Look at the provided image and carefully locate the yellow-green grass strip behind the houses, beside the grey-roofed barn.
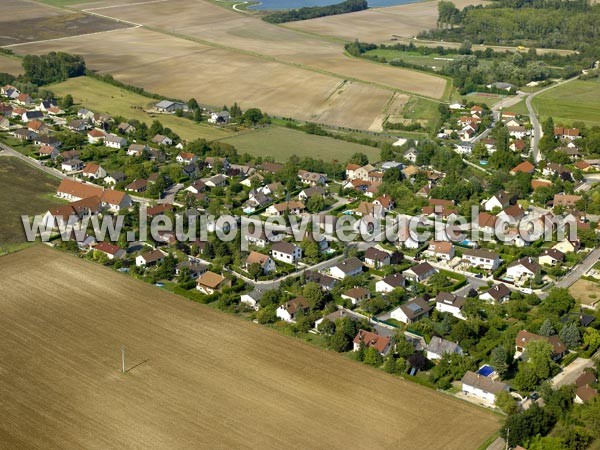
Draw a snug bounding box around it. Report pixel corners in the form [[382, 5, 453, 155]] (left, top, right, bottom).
[[48, 77, 233, 141]]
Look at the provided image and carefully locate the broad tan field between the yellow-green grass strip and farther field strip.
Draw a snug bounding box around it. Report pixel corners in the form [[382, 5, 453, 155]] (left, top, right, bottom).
[[15, 28, 398, 129]]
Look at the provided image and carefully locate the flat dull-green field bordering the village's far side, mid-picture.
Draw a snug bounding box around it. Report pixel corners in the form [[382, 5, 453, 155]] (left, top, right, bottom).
[[220, 126, 379, 162]]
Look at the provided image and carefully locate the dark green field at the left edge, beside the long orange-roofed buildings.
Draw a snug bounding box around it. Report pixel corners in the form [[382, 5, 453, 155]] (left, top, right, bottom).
[[0, 156, 61, 254]]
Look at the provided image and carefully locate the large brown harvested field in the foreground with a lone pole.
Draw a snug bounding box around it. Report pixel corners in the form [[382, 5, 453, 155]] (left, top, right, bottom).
[[0, 246, 498, 450]]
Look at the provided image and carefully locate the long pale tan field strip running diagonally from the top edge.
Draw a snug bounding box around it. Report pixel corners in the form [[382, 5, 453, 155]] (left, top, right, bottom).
[[77, 0, 446, 98]]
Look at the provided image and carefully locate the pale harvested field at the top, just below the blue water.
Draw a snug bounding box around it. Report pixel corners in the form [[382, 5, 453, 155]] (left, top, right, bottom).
[[285, 0, 487, 42]]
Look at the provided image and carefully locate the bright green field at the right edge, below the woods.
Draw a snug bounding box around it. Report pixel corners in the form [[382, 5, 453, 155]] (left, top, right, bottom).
[[533, 78, 600, 126]]
